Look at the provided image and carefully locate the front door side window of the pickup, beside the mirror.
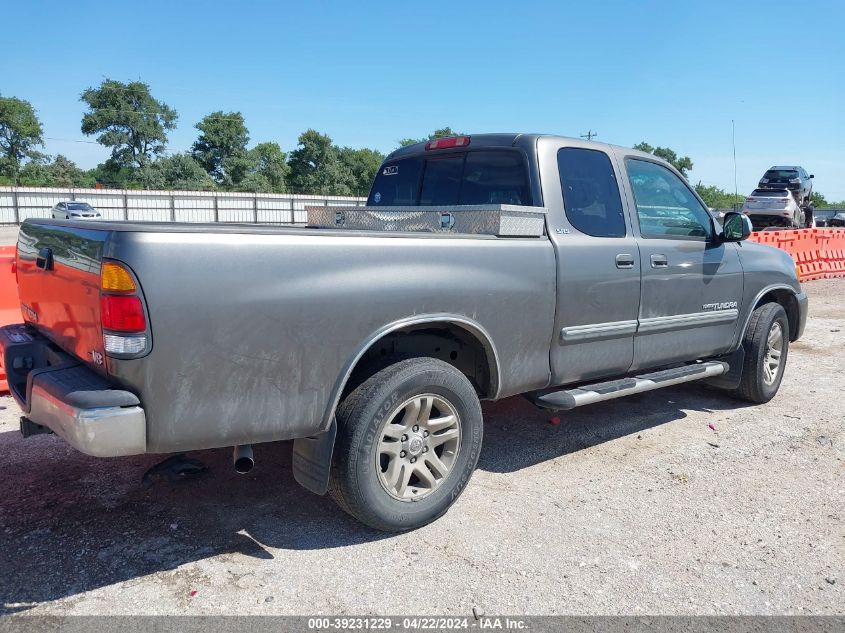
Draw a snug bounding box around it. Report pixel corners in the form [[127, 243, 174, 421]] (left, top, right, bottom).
[[625, 158, 713, 240]]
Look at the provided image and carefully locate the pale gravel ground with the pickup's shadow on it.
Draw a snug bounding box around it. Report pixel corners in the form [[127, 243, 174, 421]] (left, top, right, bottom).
[[0, 280, 845, 615]]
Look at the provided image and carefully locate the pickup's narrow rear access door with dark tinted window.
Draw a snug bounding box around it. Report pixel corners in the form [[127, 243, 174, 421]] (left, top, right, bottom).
[[538, 139, 640, 385]]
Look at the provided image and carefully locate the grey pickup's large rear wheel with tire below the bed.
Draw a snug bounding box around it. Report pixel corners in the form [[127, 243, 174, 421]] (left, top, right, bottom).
[[329, 358, 483, 532]]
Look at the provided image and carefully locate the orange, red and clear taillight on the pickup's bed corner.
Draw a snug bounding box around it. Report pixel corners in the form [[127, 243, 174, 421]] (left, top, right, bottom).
[[100, 262, 147, 354]]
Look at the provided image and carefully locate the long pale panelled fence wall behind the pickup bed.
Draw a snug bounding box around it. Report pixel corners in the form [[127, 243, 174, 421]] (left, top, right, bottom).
[[0, 187, 366, 224]]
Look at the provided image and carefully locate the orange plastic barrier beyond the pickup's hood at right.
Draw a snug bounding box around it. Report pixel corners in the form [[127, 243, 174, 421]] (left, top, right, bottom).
[[749, 229, 845, 281]]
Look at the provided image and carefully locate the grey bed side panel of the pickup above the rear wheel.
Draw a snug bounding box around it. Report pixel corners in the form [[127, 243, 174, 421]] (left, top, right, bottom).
[[107, 231, 555, 452]]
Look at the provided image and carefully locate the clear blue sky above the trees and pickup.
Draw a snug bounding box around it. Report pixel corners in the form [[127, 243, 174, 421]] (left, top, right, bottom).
[[0, 0, 845, 200]]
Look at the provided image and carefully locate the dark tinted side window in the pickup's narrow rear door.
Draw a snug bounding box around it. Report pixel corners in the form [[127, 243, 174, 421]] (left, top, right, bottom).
[[557, 147, 626, 237]]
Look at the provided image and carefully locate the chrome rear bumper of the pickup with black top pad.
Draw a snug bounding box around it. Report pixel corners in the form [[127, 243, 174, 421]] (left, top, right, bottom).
[[0, 325, 147, 457]]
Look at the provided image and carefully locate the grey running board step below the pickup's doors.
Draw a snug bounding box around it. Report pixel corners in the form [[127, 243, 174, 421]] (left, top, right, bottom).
[[531, 361, 730, 411]]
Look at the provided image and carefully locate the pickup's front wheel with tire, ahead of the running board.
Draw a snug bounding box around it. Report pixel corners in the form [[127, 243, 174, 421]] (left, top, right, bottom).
[[734, 303, 789, 404]]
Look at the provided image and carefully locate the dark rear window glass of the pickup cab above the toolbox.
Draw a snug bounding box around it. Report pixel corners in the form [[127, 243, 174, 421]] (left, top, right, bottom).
[[367, 150, 533, 206]]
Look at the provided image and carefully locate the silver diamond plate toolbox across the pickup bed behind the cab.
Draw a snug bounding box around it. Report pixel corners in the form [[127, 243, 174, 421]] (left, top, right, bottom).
[[305, 204, 546, 237]]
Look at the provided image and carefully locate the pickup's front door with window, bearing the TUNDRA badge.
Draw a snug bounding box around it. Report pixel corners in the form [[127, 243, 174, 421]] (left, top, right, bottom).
[[621, 156, 743, 369]]
